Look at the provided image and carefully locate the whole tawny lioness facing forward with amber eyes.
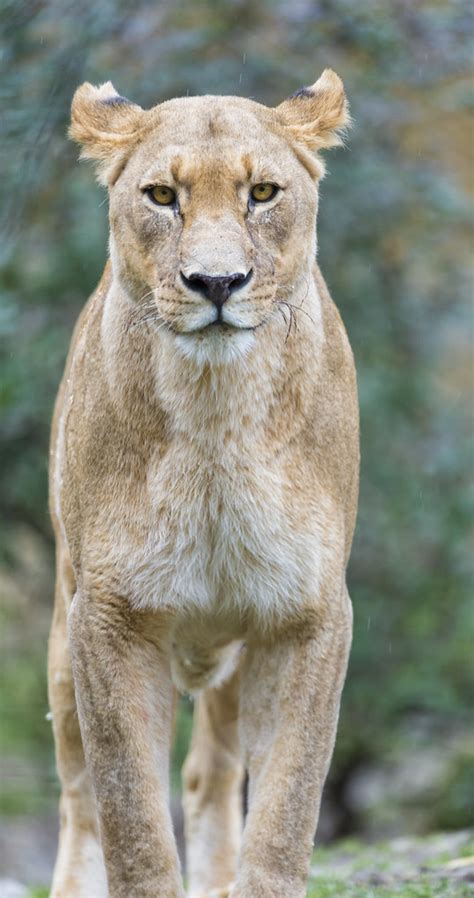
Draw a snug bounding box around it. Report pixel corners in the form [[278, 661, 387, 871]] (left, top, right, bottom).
[[49, 70, 358, 898]]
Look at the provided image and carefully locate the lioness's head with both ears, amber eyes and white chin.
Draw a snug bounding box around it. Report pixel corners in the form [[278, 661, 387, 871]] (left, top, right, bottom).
[[70, 69, 348, 355]]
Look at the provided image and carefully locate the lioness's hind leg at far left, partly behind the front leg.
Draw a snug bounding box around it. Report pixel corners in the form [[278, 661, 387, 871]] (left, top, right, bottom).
[[48, 552, 108, 898]]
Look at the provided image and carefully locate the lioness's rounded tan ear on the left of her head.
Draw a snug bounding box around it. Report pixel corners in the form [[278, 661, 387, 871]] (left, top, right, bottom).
[[69, 81, 145, 184]]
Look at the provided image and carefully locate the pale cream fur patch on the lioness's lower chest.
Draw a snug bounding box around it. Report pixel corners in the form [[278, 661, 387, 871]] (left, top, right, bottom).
[[108, 443, 324, 618]]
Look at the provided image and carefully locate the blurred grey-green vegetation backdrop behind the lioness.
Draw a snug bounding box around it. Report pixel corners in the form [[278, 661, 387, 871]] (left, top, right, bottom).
[[0, 0, 474, 881]]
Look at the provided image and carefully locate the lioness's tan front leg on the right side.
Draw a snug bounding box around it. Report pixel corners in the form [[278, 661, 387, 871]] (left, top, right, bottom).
[[234, 591, 352, 898]]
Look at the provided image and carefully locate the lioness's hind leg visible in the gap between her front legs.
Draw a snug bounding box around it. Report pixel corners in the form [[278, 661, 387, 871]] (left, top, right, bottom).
[[183, 674, 243, 898]]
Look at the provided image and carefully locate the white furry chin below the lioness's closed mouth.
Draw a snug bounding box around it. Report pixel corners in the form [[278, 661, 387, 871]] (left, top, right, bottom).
[[175, 325, 256, 365]]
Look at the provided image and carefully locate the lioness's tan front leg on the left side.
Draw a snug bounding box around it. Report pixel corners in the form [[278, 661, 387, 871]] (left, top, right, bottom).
[[69, 593, 184, 898]]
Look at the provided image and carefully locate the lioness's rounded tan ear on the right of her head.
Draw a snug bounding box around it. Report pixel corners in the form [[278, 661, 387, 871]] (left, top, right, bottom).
[[276, 69, 350, 151]]
